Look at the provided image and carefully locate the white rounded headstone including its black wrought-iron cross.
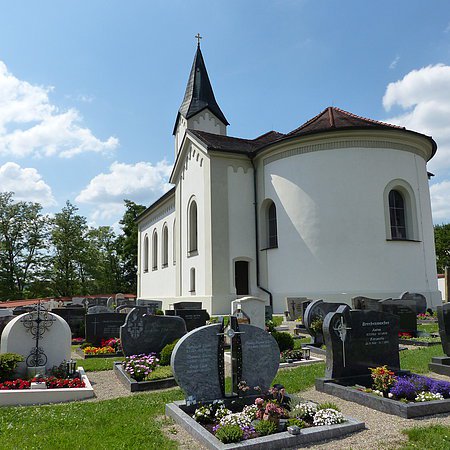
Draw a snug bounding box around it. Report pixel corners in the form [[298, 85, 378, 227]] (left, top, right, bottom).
[[0, 306, 71, 377]]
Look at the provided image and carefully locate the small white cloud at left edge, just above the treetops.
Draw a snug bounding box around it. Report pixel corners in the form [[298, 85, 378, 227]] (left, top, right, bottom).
[[0, 162, 56, 206]]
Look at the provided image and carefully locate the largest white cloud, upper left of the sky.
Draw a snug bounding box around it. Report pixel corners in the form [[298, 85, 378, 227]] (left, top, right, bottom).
[[0, 61, 119, 158]]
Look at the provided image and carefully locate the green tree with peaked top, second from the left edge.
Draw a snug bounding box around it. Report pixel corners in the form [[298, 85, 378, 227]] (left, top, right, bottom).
[[51, 201, 91, 296]]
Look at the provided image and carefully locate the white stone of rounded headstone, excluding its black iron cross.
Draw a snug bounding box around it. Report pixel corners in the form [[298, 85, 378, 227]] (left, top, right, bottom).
[[0, 312, 72, 376]]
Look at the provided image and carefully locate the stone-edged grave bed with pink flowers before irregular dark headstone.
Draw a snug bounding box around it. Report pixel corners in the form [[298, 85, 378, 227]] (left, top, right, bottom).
[[114, 353, 177, 392]]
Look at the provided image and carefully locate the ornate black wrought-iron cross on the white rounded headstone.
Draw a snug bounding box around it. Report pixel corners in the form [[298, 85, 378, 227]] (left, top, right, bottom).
[[20, 301, 56, 367]]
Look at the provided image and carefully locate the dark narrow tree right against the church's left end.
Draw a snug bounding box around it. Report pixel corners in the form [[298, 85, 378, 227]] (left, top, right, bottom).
[[118, 200, 145, 293]]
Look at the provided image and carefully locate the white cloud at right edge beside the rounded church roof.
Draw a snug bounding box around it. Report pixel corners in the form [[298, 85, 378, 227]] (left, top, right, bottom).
[[383, 64, 450, 175]]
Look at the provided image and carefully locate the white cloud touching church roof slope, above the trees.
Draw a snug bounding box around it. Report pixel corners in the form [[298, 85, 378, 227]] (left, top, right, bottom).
[[75, 160, 172, 222]]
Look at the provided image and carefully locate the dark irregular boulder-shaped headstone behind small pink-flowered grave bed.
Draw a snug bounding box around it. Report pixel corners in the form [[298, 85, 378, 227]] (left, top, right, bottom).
[[120, 307, 187, 356]]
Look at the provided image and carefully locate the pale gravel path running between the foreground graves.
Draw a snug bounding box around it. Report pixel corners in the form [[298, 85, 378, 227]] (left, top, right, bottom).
[[82, 370, 450, 450]]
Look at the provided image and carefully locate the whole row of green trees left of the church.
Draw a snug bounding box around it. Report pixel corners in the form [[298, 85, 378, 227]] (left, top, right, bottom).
[[0, 192, 145, 301]]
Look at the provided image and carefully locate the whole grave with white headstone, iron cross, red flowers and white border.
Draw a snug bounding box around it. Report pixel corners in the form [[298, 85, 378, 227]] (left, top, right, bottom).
[[0, 304, 94, 406]]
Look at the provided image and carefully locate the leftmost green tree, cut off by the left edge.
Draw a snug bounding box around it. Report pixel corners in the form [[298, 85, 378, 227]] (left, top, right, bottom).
[[0, 192, 48, 300]]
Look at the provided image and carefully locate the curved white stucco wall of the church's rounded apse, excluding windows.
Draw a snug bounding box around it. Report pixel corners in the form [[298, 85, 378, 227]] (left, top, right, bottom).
[[259, 132, 440, 312]]
